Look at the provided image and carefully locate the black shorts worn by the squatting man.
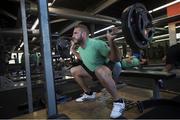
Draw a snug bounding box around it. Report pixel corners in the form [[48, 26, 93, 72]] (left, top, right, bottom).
[[73, 60, 115, 80]]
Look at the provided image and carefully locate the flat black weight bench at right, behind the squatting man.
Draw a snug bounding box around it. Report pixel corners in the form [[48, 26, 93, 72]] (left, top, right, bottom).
[[120, 70, 180, 112]]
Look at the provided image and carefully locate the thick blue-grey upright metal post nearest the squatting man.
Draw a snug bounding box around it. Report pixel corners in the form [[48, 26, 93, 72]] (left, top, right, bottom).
[[39, 0, 57, 118]]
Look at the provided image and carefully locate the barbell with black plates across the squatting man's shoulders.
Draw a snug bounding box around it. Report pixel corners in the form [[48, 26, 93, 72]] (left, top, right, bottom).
[[56, 3, 155, 57]]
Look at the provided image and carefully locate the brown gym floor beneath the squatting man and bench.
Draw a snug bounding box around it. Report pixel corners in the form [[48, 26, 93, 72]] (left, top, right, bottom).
[[15, 84, 177, 119]]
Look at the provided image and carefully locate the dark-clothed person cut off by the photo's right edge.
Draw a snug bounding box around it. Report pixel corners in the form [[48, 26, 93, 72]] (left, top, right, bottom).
[[164, 41, 180, 72]]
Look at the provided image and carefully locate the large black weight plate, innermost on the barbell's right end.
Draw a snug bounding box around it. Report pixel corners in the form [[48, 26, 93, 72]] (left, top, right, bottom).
[[122, 3, 153, 50]]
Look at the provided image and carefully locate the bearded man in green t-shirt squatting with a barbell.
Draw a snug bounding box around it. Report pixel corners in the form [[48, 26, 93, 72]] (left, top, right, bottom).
[[71, 24, 125, 118]]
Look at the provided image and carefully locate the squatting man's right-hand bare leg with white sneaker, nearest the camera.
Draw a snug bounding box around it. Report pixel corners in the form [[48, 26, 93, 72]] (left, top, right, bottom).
[[95, 66, 125, 118]]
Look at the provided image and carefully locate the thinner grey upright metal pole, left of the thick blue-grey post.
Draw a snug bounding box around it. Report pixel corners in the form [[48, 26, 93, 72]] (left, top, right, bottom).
[[20, 0, 33, 113]]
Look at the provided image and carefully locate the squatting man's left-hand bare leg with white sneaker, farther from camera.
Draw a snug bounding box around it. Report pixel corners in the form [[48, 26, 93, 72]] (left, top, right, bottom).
[[70, 65, 96, 102]]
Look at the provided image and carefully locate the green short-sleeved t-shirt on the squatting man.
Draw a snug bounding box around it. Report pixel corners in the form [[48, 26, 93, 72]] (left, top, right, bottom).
[[78, 38, 110, 71]]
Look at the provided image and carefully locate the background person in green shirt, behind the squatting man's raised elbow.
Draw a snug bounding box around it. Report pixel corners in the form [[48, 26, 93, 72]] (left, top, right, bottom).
[[122, 50, 140, 69]]
